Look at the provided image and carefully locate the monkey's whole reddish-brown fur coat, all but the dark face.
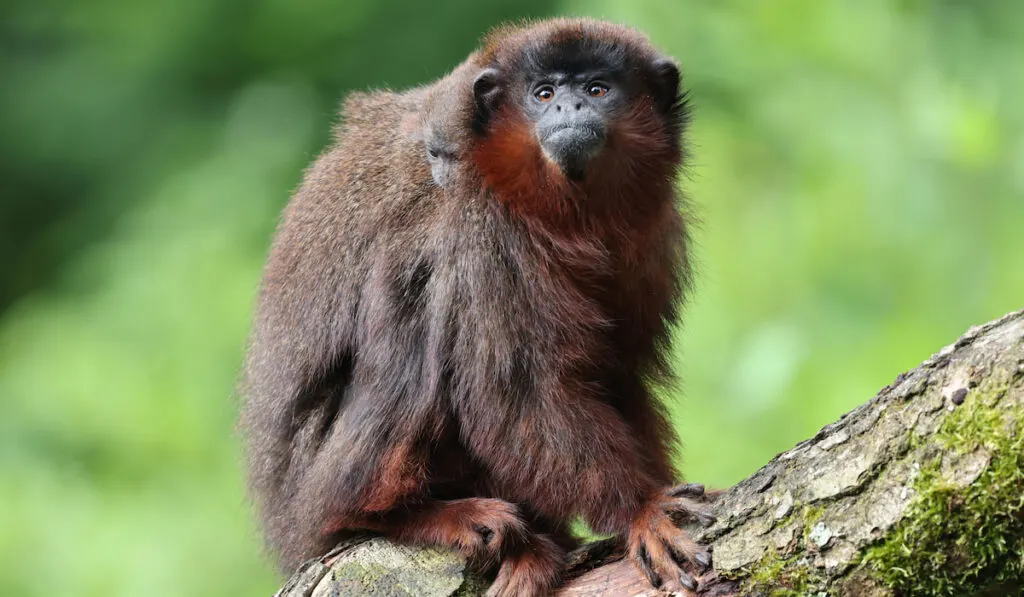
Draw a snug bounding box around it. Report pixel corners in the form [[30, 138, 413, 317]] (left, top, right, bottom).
[[242, 19, 696, 596]]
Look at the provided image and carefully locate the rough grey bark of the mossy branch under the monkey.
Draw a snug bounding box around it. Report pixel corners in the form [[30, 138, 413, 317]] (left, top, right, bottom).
[[278, 310, 1024, 597]]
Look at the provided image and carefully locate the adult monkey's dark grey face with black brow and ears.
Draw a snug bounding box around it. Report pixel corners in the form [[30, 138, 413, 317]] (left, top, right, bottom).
[[473, 36, 679, 180]]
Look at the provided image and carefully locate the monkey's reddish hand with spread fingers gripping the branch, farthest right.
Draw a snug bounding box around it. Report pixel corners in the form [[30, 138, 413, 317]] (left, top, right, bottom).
[[628, 483, 715, 594]]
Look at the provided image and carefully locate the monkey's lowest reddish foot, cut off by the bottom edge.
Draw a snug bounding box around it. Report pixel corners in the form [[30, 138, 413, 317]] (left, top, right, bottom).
[[484, 535, 567, 597]]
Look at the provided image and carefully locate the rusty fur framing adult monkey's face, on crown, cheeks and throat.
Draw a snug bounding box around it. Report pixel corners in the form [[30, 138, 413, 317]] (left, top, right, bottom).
[[470, 18, 686, 228]]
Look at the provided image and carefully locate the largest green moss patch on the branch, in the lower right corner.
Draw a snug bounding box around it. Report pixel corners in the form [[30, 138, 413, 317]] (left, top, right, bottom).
[[864, 385, 1024, 597]]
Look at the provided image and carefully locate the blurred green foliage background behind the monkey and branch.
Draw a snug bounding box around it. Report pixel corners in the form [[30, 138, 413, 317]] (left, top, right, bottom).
[[0, 0, 1024, 597]]
